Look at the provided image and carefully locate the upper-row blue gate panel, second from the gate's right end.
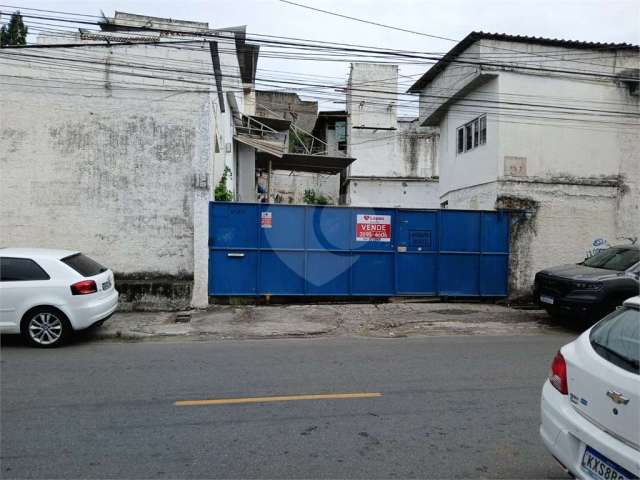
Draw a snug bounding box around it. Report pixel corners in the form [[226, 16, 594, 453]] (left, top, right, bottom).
[[440, 210, 482, 252]]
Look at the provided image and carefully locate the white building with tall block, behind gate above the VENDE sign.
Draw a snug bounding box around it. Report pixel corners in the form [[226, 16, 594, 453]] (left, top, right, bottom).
[[343, 63, 439, 208]]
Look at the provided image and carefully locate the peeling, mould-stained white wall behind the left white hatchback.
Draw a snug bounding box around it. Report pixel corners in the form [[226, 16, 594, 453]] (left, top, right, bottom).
[[0, 35, 242, 307]]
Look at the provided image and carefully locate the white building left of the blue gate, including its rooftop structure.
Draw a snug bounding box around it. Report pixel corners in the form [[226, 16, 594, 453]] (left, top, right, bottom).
[[0, 12, 257, 308]]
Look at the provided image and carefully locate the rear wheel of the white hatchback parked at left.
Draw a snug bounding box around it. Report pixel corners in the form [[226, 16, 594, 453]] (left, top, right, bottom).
[[21, 307, 72, 348]]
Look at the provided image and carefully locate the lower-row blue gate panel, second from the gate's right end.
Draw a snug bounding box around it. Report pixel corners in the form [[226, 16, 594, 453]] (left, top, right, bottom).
[[438, 254, 480, 297]]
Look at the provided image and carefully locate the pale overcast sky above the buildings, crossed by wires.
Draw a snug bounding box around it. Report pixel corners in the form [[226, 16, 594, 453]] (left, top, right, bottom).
[[2, 0, 640, 114]]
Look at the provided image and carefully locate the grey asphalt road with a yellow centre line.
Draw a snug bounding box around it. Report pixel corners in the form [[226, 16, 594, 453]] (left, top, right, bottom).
[[1, 332, 572, 478]]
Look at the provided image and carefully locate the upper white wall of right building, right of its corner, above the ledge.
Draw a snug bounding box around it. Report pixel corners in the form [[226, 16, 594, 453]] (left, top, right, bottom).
[[499, 72, 640, 178]]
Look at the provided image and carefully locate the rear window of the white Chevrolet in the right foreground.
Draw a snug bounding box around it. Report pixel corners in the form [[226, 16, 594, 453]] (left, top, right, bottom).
[[589, 307, 640, 373]]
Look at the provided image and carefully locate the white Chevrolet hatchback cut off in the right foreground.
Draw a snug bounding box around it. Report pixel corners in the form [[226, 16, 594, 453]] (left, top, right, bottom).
[[540, 297, 640, 480]]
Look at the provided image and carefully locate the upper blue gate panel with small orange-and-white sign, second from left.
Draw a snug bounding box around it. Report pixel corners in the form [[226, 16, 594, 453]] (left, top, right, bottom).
[[260, 205, 305, 250]]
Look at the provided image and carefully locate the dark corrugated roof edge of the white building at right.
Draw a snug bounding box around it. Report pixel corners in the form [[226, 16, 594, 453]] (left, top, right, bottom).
[[407, 32, 640, 93]]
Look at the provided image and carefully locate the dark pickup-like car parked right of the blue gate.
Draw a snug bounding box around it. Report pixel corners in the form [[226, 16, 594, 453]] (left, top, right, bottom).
[[534, 245, 640, 321]]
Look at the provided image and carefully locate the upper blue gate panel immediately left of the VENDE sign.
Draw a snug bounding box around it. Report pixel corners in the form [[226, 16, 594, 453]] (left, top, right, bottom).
[[305, 207, 353, 250]]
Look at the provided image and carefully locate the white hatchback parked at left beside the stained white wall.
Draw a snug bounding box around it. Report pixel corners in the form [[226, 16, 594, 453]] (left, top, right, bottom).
[[0, 248, 118, 347]]
